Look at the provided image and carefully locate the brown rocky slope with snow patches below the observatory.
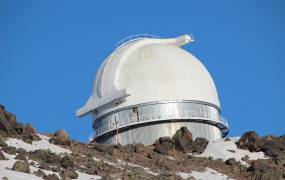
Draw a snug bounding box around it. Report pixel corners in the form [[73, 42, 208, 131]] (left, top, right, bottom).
[[0, 105, 285, 180]]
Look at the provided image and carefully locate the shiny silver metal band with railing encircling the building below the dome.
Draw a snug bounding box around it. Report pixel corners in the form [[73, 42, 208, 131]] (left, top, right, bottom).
[[93, 101, 228, 138]]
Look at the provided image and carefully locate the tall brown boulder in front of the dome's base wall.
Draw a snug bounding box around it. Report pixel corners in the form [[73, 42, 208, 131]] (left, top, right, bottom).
[[172, 127, 193, 152]]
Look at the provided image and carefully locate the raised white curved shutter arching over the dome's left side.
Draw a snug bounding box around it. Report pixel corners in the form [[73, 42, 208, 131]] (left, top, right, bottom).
[[76, 35, 196, 116]]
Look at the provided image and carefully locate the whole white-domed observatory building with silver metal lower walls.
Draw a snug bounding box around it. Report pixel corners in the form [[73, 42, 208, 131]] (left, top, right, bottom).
[[76, 35, 229, 145]]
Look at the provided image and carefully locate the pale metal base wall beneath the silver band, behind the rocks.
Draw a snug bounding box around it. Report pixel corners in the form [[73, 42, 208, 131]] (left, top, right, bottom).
[[95, 121, 222, 145]]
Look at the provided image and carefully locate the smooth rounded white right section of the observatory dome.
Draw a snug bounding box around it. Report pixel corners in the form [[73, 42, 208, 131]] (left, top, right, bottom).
[[115, 43, 220, 107]]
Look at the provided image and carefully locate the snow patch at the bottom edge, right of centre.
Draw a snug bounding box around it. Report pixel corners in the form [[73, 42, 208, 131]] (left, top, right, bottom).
[[176, 168, 232, 180]]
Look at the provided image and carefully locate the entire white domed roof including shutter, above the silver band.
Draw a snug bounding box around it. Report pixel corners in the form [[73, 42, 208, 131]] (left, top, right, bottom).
[[77, 35, 220, 116]]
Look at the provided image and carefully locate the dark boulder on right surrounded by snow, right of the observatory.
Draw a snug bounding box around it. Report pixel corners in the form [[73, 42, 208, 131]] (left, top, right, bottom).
[[236, 131, 263, 152]]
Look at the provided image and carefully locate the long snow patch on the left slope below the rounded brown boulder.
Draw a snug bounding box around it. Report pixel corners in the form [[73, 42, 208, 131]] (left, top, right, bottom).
[[6, 134, 71, 154]]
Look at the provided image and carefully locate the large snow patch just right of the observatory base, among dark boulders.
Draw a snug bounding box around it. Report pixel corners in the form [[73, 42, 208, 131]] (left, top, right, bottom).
[[195, 137, 266, 165]]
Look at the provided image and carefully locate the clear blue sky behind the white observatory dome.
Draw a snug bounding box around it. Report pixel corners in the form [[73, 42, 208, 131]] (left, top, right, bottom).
[[0, 0, 285, 141]]
